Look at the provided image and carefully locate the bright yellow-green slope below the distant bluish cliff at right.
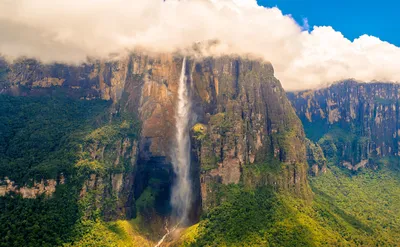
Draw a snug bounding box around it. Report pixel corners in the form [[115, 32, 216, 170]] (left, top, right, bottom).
[[311, 166, 400, 246]]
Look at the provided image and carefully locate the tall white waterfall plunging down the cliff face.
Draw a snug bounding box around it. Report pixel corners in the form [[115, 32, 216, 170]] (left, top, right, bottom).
[[171, 57, 192, 224]]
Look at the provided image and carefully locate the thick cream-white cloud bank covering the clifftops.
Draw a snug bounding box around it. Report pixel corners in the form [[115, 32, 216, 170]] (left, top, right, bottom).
[[0, 0, 400, 90]]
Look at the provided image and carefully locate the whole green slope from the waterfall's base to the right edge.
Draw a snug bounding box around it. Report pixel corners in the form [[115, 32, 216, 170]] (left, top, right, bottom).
[[176, 161, 400, 246]]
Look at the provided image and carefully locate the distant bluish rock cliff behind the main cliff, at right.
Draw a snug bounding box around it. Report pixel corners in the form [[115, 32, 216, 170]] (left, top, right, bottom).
[[288, 81, 400, 170]]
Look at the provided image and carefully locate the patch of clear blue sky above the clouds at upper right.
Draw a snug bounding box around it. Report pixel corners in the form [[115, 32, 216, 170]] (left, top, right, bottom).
[[257, 0, 400, 47]]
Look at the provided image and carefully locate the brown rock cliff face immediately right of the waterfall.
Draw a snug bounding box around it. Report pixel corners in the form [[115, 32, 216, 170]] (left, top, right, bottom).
[[188, 57, 308, 210]]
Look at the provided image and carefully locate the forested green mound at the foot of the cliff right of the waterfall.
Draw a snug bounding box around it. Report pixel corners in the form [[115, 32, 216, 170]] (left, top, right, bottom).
[[190, 188, 318, 246]]
